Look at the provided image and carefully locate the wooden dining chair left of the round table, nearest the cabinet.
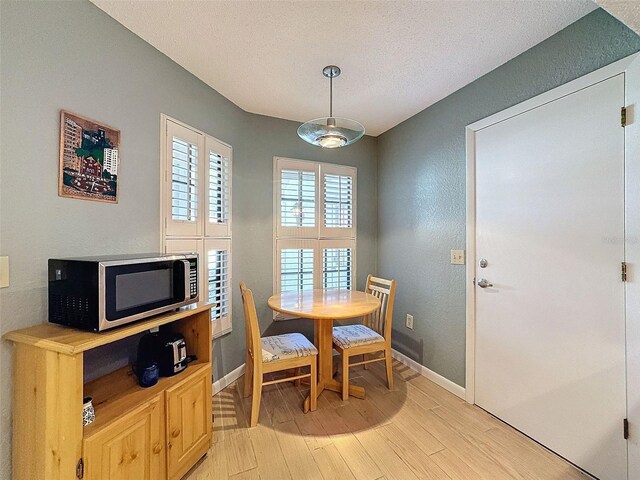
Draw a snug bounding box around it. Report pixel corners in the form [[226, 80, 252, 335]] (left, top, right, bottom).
[[240, 282, 318, 427]]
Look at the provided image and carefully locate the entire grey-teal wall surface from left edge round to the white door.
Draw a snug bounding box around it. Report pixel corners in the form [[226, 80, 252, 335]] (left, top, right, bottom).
[[0, 1, 640, 479]]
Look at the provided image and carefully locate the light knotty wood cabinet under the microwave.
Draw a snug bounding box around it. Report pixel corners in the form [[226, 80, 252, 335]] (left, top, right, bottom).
[[3, 303, 212, 480]]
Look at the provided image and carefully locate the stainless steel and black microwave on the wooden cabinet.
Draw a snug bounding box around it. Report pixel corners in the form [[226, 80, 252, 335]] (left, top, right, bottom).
[[49, 253, 198, 332]]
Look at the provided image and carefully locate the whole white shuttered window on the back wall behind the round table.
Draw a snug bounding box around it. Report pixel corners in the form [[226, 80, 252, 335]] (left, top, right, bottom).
[[273, 157, 357, 304]]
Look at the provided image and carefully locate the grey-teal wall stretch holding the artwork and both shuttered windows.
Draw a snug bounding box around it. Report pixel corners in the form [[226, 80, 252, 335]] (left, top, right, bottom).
[[0, 0, 377, 479]]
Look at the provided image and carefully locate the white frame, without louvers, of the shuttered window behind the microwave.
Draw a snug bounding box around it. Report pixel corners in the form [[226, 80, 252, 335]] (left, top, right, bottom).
[[160, 114, 233, 338]]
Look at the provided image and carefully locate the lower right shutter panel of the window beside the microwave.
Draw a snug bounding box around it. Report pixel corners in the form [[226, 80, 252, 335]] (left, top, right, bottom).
[[203, 238, 232, 337]]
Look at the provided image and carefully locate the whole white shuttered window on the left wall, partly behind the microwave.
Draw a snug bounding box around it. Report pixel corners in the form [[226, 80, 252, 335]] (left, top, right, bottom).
[[160, 114, 233, 337]]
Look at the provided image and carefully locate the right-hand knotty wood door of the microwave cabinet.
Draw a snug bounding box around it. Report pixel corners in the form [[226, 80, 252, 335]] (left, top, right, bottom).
[[166, 368, 212, 479]]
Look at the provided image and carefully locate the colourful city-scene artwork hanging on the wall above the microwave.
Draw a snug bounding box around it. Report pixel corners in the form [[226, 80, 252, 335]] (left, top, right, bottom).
[[58, 110, 120, 203]]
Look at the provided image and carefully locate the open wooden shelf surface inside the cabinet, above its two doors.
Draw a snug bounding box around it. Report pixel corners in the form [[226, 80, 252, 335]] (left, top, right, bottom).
[[84, 361, 209, 439]]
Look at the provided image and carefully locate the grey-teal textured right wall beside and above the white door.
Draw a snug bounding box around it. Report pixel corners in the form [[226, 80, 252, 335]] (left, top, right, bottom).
[[378, 10, 640, 386]]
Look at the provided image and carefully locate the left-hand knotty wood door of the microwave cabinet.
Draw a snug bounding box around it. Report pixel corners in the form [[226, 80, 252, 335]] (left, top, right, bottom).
[[84, 396, 166, 480]]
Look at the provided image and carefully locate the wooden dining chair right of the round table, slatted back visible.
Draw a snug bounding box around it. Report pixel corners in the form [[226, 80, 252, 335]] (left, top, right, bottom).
[[333, 275, 396, 400]]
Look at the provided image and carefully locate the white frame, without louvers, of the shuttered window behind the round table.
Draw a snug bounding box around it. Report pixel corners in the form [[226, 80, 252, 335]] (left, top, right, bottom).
[[273, 157, 357, 302]]
